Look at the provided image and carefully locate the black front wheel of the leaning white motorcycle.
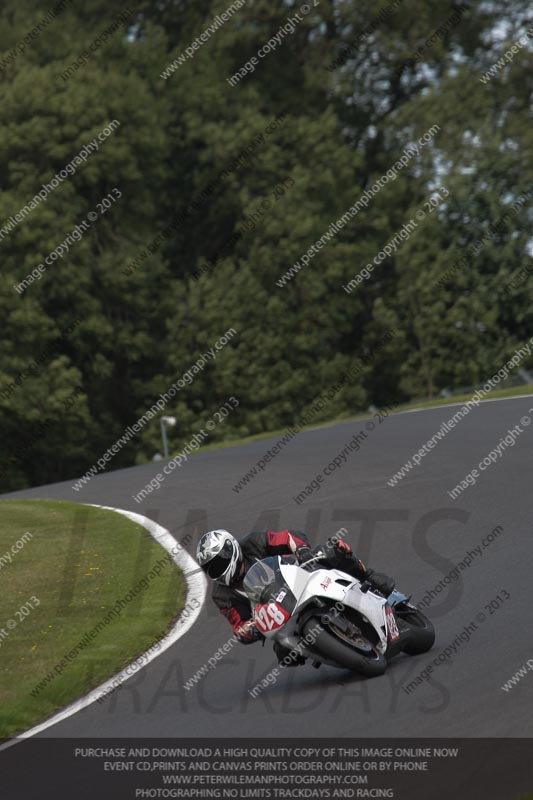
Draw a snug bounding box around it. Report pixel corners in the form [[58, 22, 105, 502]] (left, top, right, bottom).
[[302, 617, 387, 678]]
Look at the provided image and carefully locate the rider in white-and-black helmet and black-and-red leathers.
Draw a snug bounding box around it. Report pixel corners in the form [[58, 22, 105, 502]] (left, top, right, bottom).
[[196, 528, 394, 666]]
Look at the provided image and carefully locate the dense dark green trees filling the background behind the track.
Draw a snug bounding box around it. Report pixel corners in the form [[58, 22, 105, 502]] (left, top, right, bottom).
[[0, 0, 533, 490]]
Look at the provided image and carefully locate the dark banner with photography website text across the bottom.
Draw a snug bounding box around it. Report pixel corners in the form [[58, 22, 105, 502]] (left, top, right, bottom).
[[0, 738, 533, 800]]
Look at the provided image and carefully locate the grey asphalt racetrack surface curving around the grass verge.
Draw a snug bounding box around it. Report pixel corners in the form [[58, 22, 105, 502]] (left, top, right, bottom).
[[4, 396, 533, 738]]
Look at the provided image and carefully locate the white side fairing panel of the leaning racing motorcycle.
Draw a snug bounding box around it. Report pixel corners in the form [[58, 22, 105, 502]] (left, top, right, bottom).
[[265, 562, 387, 653]]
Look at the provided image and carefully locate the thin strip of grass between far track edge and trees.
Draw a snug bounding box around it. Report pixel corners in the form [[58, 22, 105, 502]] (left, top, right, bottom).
[[184, 384, 533, 455]]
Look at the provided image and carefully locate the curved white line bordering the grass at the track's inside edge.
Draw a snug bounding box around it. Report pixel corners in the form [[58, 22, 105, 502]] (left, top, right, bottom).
[[0, 503, 207, 750]]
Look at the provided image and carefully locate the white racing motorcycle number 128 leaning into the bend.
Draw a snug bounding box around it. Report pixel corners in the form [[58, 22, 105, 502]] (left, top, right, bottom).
[[243, 553, 435, 677]]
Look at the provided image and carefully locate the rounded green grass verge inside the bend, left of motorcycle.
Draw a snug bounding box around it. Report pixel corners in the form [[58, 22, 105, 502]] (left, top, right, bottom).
[[0, 500, 185, 737]]
